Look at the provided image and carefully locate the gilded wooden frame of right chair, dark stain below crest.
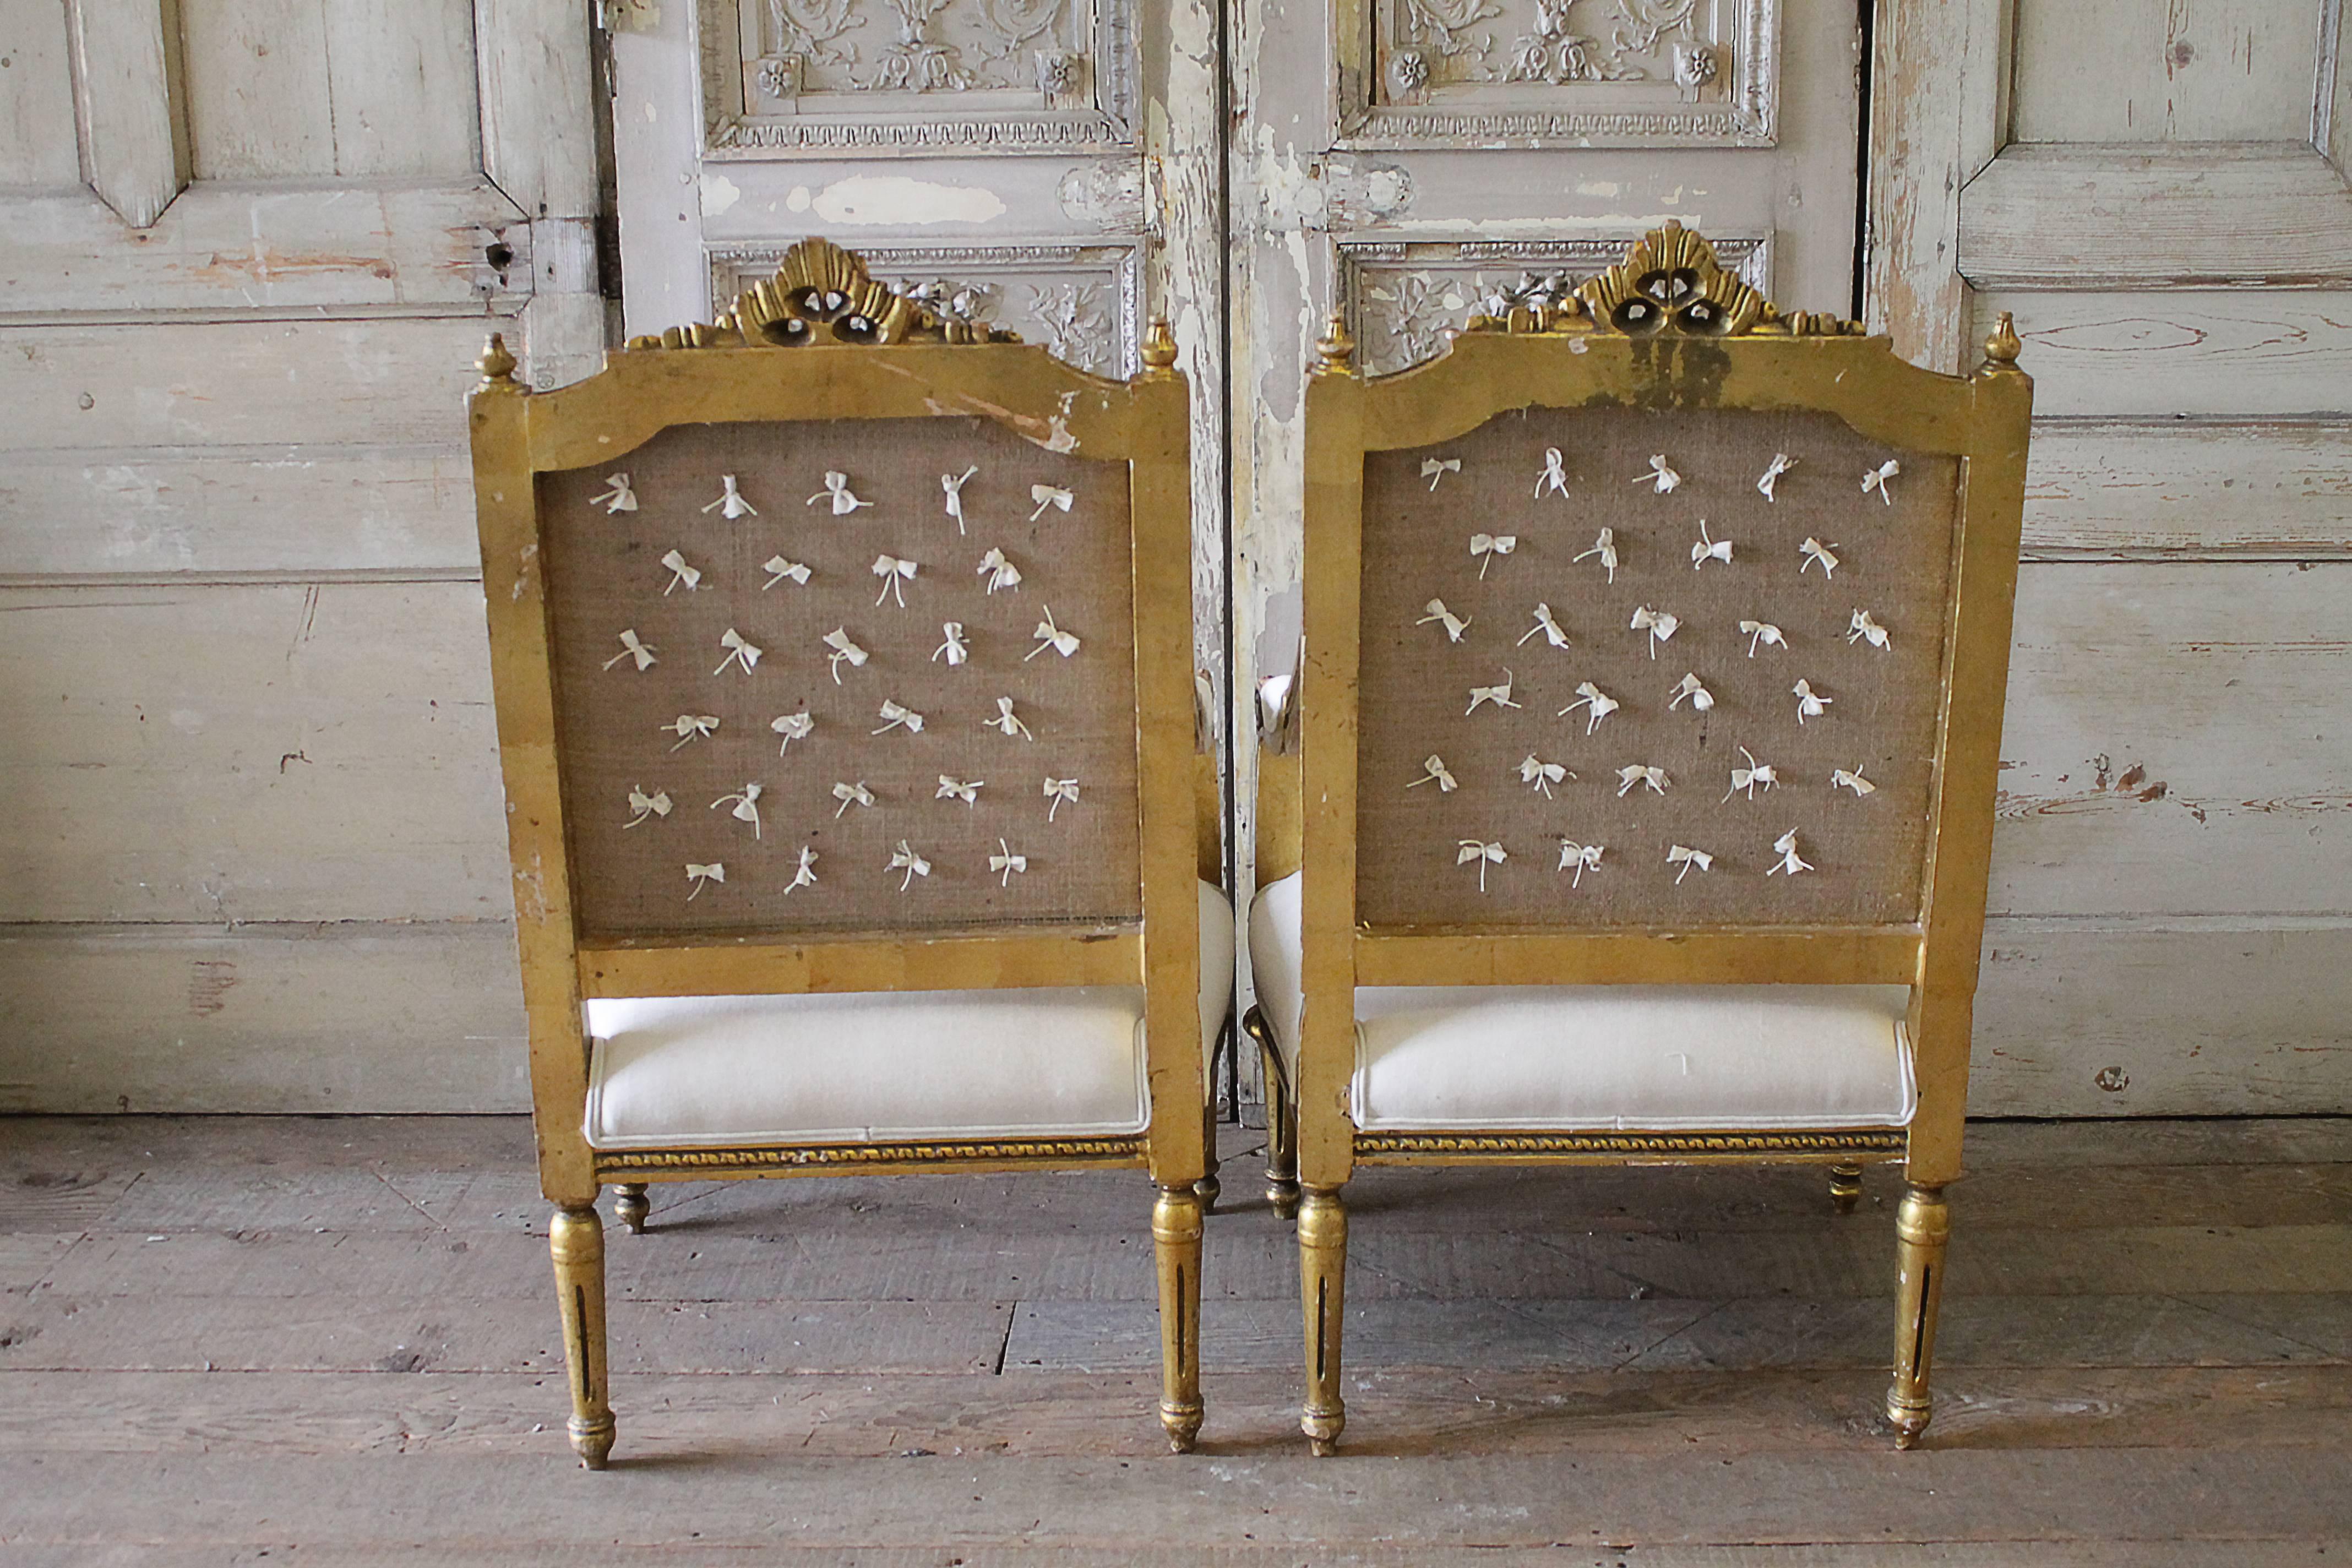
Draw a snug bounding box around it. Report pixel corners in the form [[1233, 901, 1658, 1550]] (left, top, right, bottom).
[[1289, 224, 2032, 1453]]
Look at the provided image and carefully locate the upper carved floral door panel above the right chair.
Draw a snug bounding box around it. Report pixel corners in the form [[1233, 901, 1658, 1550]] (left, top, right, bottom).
[[1343, 0, 1781, 148]]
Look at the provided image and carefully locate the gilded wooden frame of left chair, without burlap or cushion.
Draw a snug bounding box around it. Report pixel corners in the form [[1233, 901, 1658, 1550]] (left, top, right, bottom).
[[468, 240, 1216, 1469]]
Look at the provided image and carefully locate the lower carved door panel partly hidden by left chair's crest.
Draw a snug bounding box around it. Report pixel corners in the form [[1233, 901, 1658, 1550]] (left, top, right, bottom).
[[710, 240, 1143, 376]]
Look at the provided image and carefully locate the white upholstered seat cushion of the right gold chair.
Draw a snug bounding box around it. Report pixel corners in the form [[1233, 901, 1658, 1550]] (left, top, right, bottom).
[[1249, 874, 1919, 1131]]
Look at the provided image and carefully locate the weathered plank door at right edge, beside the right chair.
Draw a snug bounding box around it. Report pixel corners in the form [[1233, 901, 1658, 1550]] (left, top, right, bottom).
[[1870, 0, 2352, 1117]]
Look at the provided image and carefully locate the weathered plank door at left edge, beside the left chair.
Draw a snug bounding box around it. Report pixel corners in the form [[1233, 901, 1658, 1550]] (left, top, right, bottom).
[[0, 0, 605, 1112]]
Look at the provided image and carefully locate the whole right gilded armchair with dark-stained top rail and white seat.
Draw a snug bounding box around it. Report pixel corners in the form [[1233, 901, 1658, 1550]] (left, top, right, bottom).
[[1249, 224, 2032, 1453]]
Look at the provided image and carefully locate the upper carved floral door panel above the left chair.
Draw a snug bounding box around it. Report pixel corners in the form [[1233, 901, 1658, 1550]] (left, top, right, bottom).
[[696, 0, 1136, 157]]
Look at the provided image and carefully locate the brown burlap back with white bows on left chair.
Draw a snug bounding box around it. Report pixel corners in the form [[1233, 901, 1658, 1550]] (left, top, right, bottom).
[[538, 418, 1141, 938]]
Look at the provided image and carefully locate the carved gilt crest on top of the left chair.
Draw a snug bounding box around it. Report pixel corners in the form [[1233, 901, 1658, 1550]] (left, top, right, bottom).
[[628, 237, 1021, 348]]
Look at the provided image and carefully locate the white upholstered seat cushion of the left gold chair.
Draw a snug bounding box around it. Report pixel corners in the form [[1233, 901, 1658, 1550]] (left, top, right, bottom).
[[586, 884, 1235, 1150]]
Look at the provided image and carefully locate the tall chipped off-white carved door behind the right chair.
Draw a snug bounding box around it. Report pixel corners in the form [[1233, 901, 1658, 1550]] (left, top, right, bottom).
[[1233, 0, 1860, 950]]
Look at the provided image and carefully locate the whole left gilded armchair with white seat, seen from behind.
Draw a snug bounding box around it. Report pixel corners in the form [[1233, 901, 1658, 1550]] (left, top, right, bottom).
[[470, 240, 1233, 1469]]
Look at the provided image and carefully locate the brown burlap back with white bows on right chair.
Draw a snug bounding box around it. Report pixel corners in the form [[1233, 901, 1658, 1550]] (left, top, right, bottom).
[[1357, 409, 1957, 929]]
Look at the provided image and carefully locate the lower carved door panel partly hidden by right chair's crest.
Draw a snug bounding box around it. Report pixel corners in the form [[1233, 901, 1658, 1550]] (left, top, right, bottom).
[[1341, 237, 1771, 376]]
